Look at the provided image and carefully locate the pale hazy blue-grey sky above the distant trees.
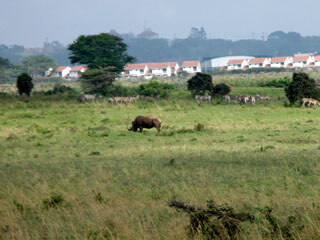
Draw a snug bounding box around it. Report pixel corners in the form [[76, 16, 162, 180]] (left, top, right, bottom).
[[0, 0, 320, 47]]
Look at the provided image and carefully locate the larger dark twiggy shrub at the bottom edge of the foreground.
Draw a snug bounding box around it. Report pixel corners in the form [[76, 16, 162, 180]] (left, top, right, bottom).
[[169, 200, 255, 239]]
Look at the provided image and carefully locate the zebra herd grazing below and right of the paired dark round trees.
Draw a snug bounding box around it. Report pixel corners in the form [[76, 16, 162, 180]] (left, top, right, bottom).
[[195, 94, 270, 104]]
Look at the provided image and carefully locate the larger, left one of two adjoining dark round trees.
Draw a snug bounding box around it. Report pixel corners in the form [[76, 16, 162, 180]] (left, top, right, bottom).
[[188, 73, 213, 95]]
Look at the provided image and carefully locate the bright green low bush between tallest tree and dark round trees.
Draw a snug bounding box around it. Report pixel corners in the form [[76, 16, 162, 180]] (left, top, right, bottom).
[[137, 80, 176, 98]]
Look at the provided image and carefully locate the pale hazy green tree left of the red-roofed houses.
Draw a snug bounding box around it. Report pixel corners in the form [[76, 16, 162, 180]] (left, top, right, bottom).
[[22, 55, 58, 76]]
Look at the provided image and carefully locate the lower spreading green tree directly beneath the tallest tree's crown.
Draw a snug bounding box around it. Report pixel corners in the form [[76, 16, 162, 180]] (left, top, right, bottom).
[[80, 67, 118, 95]]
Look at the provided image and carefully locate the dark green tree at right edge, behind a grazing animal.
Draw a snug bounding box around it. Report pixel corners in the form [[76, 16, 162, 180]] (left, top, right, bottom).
[[285, 72, 320, 104]]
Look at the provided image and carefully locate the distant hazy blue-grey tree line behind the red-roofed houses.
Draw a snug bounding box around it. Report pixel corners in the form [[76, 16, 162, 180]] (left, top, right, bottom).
[[0, 28, 320, 65]]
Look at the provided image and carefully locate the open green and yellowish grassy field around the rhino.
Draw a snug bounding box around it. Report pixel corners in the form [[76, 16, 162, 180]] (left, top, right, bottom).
[[0, 88, 320, 239]]
